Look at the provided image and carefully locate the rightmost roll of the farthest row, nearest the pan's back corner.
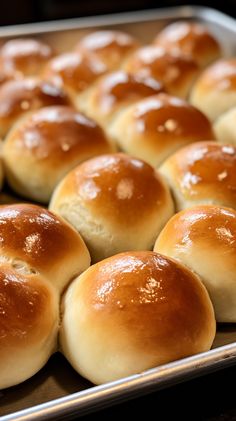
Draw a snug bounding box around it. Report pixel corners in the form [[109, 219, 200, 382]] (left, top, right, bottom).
[[154, 21, 221, 66]]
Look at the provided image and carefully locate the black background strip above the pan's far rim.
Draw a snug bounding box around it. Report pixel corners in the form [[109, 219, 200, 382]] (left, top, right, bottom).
[[0, 0, 236, 25]]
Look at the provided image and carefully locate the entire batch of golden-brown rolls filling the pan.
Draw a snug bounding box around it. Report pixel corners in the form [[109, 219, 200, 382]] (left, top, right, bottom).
[[0, 21, 236, 389]]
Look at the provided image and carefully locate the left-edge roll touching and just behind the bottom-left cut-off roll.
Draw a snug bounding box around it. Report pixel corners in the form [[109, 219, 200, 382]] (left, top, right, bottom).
[[0, 204, 90, 292]]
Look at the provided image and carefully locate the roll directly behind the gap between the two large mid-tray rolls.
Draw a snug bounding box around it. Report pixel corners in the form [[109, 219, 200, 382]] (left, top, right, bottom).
[[81, 70, 163, 126]]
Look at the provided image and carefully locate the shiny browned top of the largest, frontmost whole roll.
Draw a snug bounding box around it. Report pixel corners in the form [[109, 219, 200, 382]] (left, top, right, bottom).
[[79, 251, 214, 352]]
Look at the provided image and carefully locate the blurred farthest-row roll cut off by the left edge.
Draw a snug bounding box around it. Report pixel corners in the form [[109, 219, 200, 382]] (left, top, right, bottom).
[[0, 38, 53, 76]]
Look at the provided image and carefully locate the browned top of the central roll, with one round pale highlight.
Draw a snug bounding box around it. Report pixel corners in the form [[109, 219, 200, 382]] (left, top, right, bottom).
[[55, 153, 169, 229]]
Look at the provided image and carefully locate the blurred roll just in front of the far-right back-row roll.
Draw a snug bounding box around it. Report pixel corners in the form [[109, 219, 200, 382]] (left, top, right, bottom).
[[124, 46, 199, 98]]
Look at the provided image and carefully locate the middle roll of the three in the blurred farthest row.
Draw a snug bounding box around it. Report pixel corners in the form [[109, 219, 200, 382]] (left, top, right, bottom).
[[75, 30, 140, 70]]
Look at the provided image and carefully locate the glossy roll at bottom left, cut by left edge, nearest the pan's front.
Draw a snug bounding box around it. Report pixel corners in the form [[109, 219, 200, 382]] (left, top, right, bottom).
[[0, 264, 59, 389]]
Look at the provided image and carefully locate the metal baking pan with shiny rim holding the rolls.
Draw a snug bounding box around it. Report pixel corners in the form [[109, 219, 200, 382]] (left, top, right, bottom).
[[0, 6, 236, 421]]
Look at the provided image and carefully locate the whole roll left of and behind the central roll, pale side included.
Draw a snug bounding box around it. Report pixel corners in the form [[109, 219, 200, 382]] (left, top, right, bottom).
[[2, 106, 114, 203]]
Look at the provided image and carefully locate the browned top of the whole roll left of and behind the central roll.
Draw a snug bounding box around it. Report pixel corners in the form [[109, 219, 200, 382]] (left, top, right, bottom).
[[6, 106, 112, 164]]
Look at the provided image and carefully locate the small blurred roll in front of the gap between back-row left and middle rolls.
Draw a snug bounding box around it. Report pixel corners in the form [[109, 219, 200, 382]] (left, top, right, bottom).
[[43, 52, 107, 93]]
